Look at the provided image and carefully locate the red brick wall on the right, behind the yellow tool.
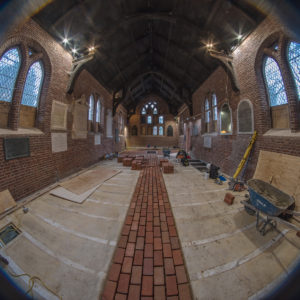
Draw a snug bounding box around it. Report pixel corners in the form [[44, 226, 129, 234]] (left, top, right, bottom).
[[191, 15, 300, 178]]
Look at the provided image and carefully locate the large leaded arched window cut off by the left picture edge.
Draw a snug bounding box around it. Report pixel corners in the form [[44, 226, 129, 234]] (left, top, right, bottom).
[[0, 48, 21, 102]]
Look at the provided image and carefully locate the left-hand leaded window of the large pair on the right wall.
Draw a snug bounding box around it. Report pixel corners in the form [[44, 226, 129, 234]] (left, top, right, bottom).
[[264, 57, 287, 106]]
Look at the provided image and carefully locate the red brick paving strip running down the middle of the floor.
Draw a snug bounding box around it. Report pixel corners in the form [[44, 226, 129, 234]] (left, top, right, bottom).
[[101, 155, 192, 300]]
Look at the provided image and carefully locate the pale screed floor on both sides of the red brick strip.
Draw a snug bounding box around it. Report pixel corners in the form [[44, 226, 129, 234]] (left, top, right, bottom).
[[0, 154, 300, 299]]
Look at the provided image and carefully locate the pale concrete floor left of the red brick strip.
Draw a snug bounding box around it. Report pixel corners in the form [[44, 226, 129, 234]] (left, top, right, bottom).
[[0, 161, 139, 300]]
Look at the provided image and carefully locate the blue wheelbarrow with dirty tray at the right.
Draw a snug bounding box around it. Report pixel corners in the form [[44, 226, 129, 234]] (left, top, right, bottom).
[[241, 179, 300, 235]]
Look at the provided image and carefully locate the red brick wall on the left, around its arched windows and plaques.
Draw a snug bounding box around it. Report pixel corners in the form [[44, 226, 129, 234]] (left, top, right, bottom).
[[0, 20, 114, 200]]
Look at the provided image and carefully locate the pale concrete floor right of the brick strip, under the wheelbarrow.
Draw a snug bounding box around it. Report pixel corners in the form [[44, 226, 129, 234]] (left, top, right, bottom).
[[164, 165, 300, 300]]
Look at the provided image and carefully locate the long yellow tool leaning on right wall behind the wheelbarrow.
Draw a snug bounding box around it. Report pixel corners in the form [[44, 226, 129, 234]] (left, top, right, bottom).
[[228, 131, 257, 192]]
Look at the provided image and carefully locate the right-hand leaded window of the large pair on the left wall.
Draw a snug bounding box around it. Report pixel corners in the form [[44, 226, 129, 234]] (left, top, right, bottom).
[[21, 61, 44, 107]]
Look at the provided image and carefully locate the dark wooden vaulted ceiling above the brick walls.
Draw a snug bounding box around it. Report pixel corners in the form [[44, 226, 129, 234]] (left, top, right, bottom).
[[34, 0, 265, 113]]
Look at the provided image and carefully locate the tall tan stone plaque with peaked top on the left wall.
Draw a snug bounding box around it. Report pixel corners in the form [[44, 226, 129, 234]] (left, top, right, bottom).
[[72, 97, 89, 139]]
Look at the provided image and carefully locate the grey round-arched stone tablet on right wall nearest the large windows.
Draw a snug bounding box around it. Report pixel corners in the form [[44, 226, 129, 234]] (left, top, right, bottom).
[[238, 100, 254, 133]]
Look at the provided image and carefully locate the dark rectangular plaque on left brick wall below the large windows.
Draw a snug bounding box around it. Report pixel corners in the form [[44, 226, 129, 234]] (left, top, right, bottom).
[[4, 137, 30, 160]]
